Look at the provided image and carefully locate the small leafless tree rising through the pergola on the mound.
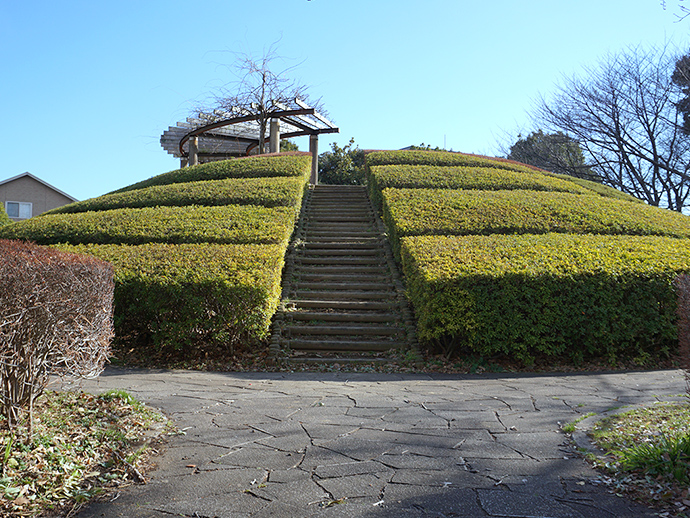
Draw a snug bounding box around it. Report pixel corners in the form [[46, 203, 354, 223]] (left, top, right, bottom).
[[196, 44, 327, 153]]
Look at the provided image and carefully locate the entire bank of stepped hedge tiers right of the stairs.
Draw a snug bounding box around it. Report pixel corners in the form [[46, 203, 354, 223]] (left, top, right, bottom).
[[367, 151, 690, 365]]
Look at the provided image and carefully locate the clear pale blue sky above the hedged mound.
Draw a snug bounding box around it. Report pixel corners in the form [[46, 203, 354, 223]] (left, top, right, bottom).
[[0, 0, 690, 199]]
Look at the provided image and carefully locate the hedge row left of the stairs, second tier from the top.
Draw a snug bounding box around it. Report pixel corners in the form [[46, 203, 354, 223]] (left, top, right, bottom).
[[44, 177, 306, 214]]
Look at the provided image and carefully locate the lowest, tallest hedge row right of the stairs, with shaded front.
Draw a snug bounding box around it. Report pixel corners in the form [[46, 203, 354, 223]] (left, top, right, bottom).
[[402, 234, 690, 364]]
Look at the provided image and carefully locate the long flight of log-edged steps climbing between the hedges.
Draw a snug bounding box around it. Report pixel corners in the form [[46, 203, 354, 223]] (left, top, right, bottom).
[[270, 185, 417, 362]]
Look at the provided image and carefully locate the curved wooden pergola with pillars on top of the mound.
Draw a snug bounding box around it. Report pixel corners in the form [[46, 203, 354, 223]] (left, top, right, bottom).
[[161, 99, 340, 184]]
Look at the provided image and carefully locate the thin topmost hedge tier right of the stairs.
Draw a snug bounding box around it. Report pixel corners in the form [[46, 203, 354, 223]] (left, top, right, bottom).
[[366, 150, 543, 173]]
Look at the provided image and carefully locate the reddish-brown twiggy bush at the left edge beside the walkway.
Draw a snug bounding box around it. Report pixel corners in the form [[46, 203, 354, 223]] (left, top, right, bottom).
[[0, 240, 113, 437]]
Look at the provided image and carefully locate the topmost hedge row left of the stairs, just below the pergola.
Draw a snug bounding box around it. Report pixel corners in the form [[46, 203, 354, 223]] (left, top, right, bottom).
[[111, 152, 311, 194]]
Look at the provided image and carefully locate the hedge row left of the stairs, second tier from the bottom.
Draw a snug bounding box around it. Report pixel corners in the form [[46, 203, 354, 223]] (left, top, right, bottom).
[[0, 205, 299, 246]]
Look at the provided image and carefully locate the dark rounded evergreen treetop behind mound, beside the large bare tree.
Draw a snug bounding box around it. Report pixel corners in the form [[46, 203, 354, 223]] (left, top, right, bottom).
[[507, 130, 600, 181]]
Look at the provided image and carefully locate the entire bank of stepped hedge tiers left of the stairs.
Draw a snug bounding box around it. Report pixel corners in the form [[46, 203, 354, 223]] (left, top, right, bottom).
[[0, 153, 311, 361]]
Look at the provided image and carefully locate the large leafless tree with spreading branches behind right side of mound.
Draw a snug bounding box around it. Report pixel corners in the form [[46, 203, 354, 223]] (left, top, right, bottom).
[[536, 47, 690, 211]]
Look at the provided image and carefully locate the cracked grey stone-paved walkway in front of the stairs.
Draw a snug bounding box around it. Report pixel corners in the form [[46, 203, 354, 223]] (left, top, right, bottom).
[[72, 368, 685, 518]]
